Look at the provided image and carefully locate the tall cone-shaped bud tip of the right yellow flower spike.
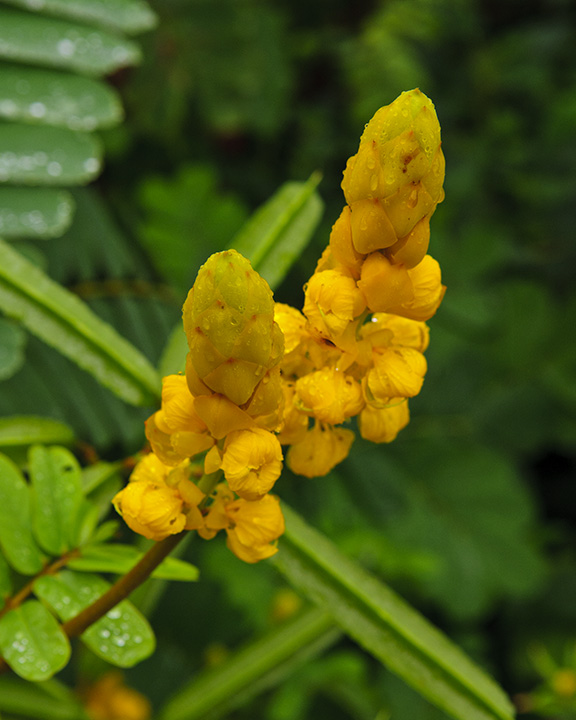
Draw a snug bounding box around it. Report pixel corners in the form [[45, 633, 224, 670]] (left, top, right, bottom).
[[342, 89, 444, 246]]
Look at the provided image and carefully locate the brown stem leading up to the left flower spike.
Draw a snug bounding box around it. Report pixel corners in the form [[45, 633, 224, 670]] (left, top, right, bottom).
[[62, 531, 186, 637]]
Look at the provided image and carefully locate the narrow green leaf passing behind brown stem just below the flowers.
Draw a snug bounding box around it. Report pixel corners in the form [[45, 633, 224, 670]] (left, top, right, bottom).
[[68, 543, 198, 582]]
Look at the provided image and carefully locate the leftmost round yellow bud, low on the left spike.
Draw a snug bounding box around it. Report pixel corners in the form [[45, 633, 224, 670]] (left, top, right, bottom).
[[112, 480, 186, 540]]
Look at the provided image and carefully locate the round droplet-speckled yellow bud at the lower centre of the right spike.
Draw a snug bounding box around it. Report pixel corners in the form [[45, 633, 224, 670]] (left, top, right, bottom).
[[295, 368, 364, 425]]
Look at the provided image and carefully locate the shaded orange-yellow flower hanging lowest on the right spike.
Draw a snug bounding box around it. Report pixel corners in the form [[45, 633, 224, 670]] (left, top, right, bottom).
[[286, 422, 354, 477]]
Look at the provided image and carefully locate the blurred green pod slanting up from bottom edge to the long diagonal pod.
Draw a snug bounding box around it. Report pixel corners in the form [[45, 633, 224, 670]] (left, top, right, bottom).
[[160, 609, 340, 720]]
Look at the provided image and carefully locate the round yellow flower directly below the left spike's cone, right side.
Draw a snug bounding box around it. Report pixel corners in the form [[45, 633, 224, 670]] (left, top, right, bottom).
[[221, 428, 282, 500]]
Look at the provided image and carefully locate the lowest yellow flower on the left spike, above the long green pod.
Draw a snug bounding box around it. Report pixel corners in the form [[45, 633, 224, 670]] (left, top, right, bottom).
[[226, 495, 284, 562]]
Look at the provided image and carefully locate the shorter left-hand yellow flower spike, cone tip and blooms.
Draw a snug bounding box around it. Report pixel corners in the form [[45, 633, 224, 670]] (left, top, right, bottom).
[[113, 250, 284, 562]]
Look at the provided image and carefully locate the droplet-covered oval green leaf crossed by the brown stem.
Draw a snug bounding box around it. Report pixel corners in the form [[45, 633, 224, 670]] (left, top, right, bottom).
[[34, 571, 156, 667]]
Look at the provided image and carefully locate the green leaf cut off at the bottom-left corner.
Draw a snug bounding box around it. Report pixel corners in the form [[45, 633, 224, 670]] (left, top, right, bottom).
[[0, 676, 88, 720]]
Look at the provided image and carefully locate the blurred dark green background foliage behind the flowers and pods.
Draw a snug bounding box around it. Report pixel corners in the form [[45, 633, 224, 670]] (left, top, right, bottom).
[[0, 0, 576, 720]]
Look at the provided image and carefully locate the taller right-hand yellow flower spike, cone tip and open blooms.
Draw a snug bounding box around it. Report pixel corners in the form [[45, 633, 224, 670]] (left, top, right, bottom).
[[276, 90, 445, 477]]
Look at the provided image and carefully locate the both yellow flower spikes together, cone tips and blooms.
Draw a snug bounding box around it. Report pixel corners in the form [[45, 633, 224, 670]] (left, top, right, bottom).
[[114, 90, 445, 562]]
